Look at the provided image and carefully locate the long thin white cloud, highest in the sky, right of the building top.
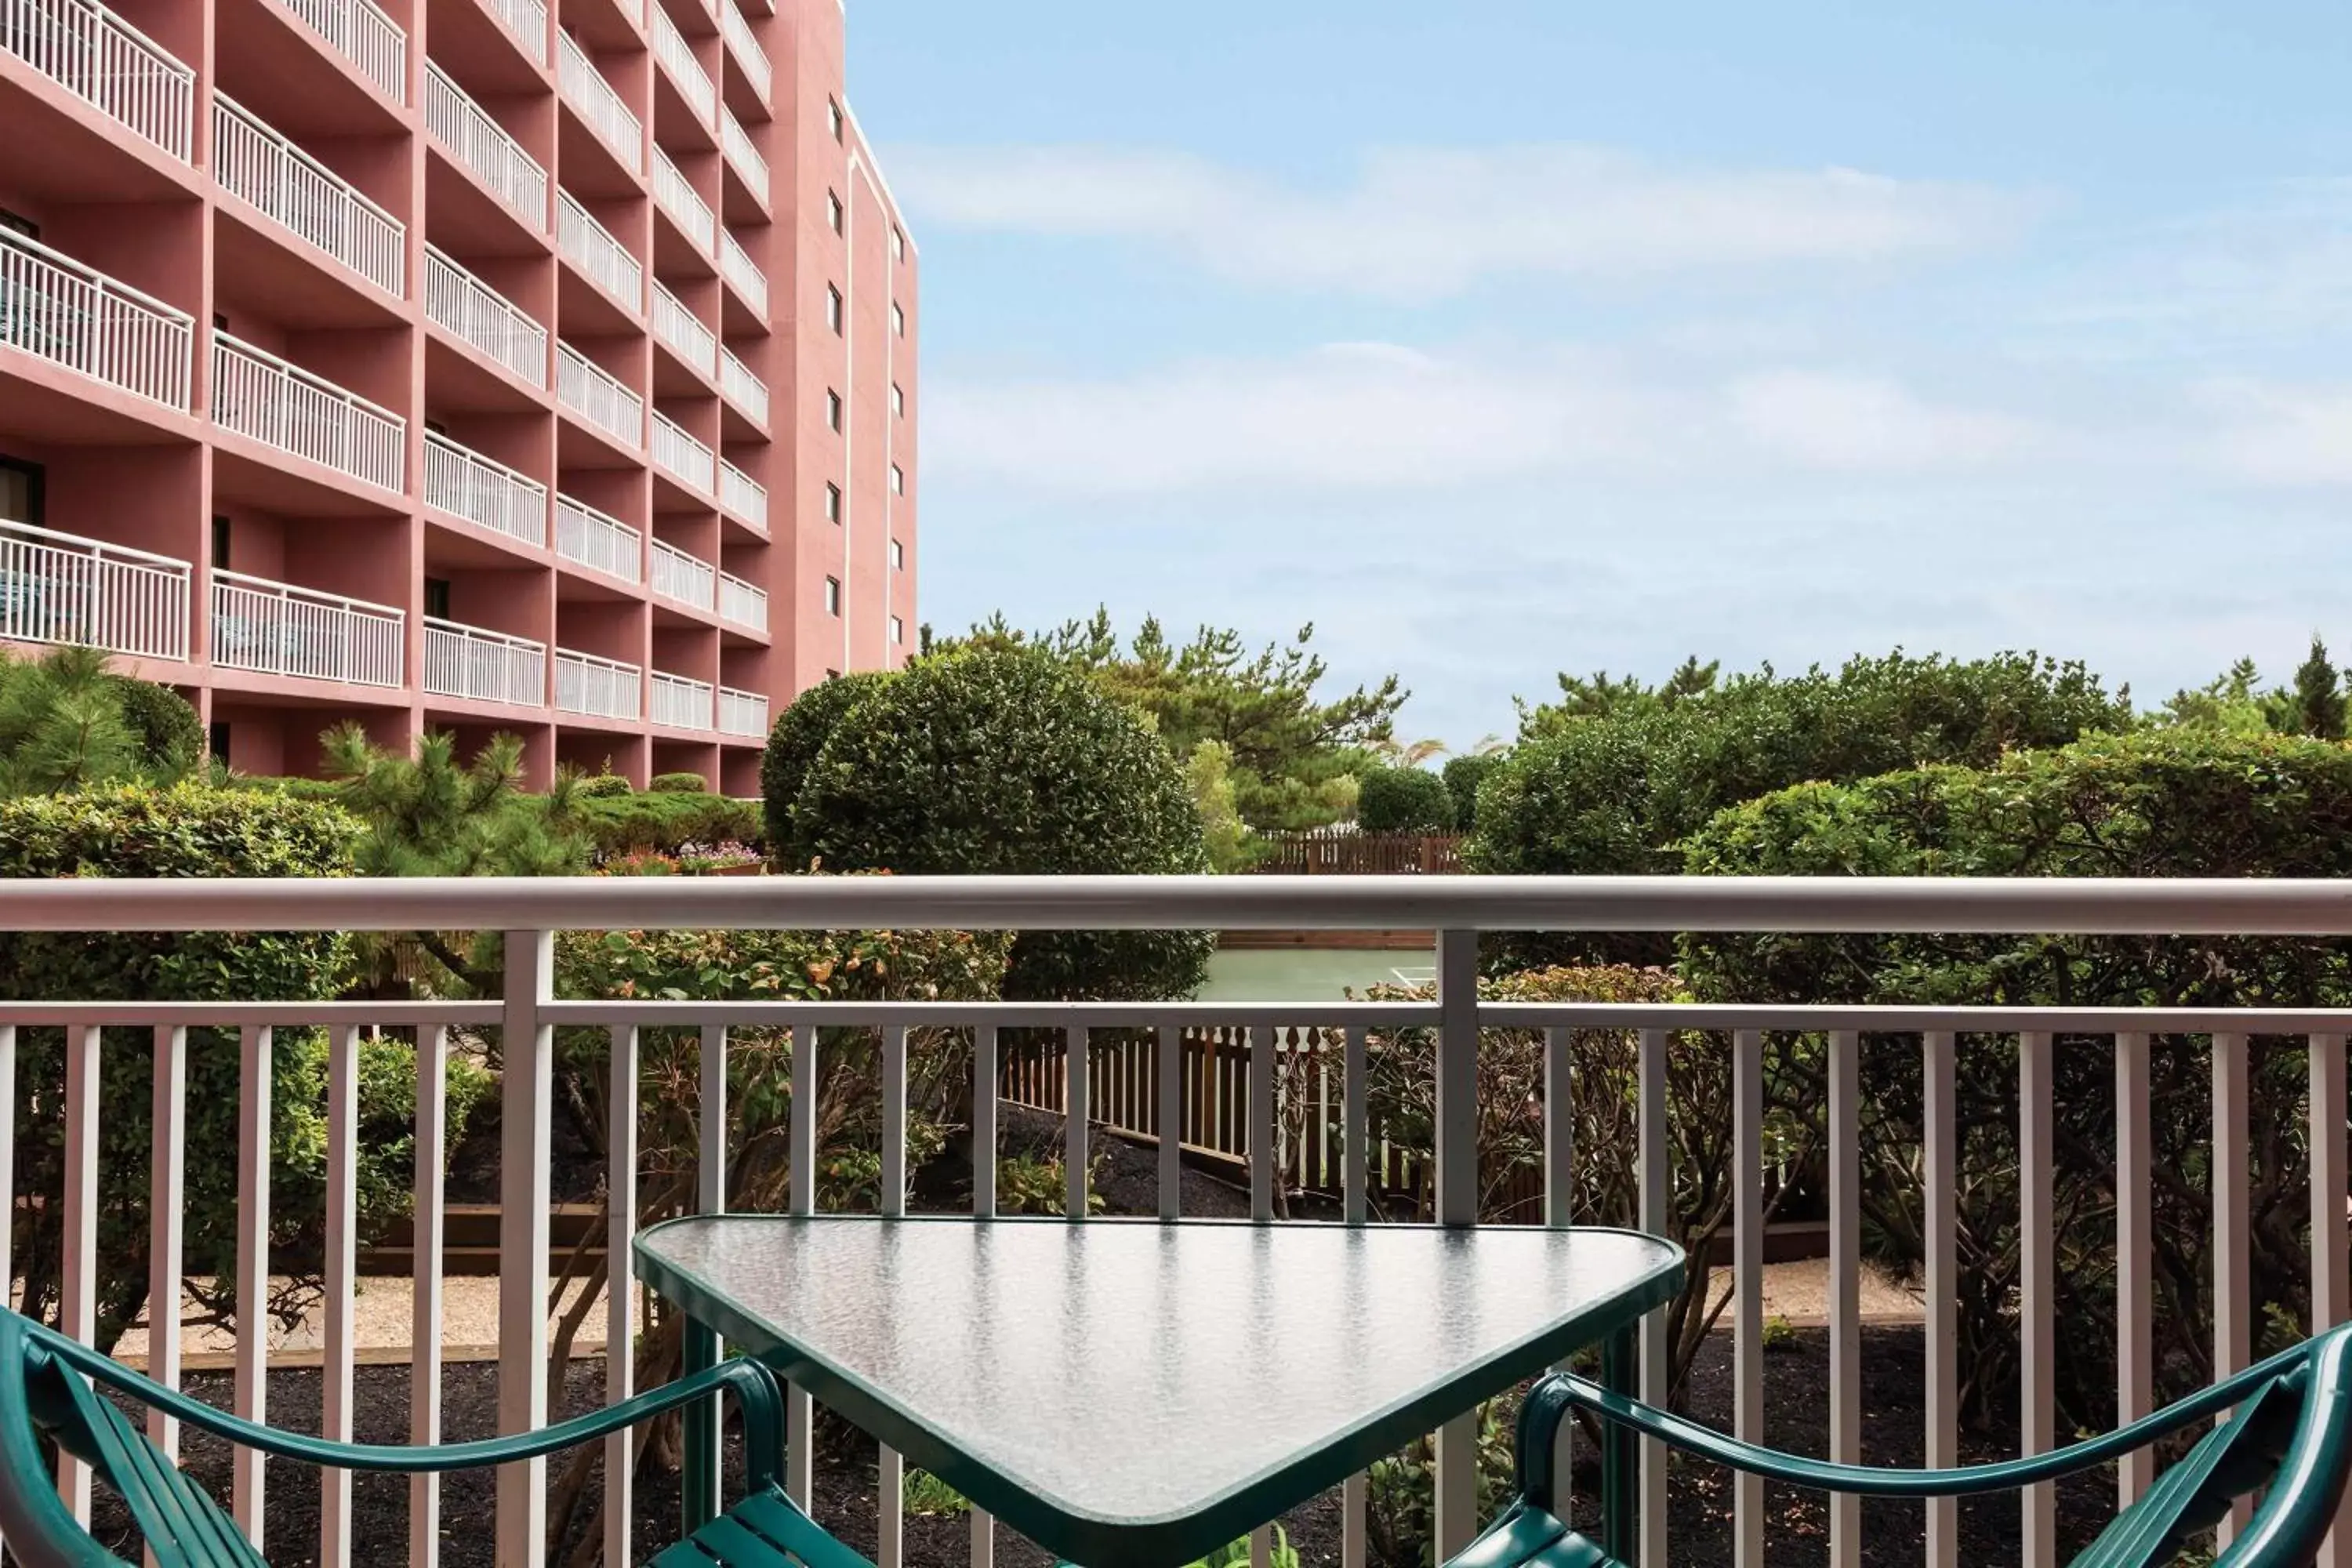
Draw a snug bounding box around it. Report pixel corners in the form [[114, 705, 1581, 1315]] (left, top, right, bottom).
[[891, 146, 2046, 299]]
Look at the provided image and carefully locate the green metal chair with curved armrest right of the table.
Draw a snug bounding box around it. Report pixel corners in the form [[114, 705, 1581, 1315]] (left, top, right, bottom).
[[1446, 1326, 2352, 1568]]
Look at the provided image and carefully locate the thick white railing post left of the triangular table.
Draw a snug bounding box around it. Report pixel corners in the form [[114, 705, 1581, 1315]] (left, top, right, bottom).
[[496, 931, 555, 1563]]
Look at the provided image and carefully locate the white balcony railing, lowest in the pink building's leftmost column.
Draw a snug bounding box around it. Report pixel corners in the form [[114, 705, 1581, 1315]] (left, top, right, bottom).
[[0, 522, 188, 661]]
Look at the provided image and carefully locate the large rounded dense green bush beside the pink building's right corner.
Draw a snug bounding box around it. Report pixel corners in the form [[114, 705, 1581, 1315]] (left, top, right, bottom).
[[793, 647, 1214, 999]]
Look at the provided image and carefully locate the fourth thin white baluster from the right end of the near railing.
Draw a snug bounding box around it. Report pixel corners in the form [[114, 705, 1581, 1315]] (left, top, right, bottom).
[[2018, 1032, 2058, 1568]]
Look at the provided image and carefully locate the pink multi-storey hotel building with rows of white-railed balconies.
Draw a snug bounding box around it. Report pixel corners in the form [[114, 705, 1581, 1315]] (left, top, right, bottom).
[[0, 0, 917, 794]]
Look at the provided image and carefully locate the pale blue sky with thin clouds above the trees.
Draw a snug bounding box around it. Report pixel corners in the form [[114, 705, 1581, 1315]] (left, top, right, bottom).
[[849, 0, 2352, 746]]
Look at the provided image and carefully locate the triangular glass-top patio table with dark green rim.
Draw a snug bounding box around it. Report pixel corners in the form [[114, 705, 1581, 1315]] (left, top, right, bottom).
[[637, 1215, 1682, 1568]]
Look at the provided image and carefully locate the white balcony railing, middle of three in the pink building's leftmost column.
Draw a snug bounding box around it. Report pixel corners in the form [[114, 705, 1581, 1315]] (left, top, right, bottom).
[[0, 227, 195, 414]]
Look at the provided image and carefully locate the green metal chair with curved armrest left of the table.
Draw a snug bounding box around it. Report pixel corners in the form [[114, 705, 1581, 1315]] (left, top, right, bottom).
[[0, 1309, 873, 1568]]
